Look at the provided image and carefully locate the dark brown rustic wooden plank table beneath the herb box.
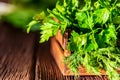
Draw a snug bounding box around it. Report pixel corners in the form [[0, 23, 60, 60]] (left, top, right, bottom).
[[0, 24, 107, 80]]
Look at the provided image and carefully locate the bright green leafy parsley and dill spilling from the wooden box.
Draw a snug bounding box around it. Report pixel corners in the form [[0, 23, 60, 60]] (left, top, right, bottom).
[[28, 0, 120, 80]]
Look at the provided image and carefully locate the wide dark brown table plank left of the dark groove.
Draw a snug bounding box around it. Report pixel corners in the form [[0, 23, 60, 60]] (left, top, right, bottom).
[[0, 25, 34, 80]]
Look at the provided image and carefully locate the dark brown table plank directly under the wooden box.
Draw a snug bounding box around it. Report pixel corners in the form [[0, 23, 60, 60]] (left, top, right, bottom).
[[35, 37, 108, 80]]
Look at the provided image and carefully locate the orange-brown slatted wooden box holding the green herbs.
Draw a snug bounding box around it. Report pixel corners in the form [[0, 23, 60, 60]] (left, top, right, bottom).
[[50, 31, 105, 76]]
